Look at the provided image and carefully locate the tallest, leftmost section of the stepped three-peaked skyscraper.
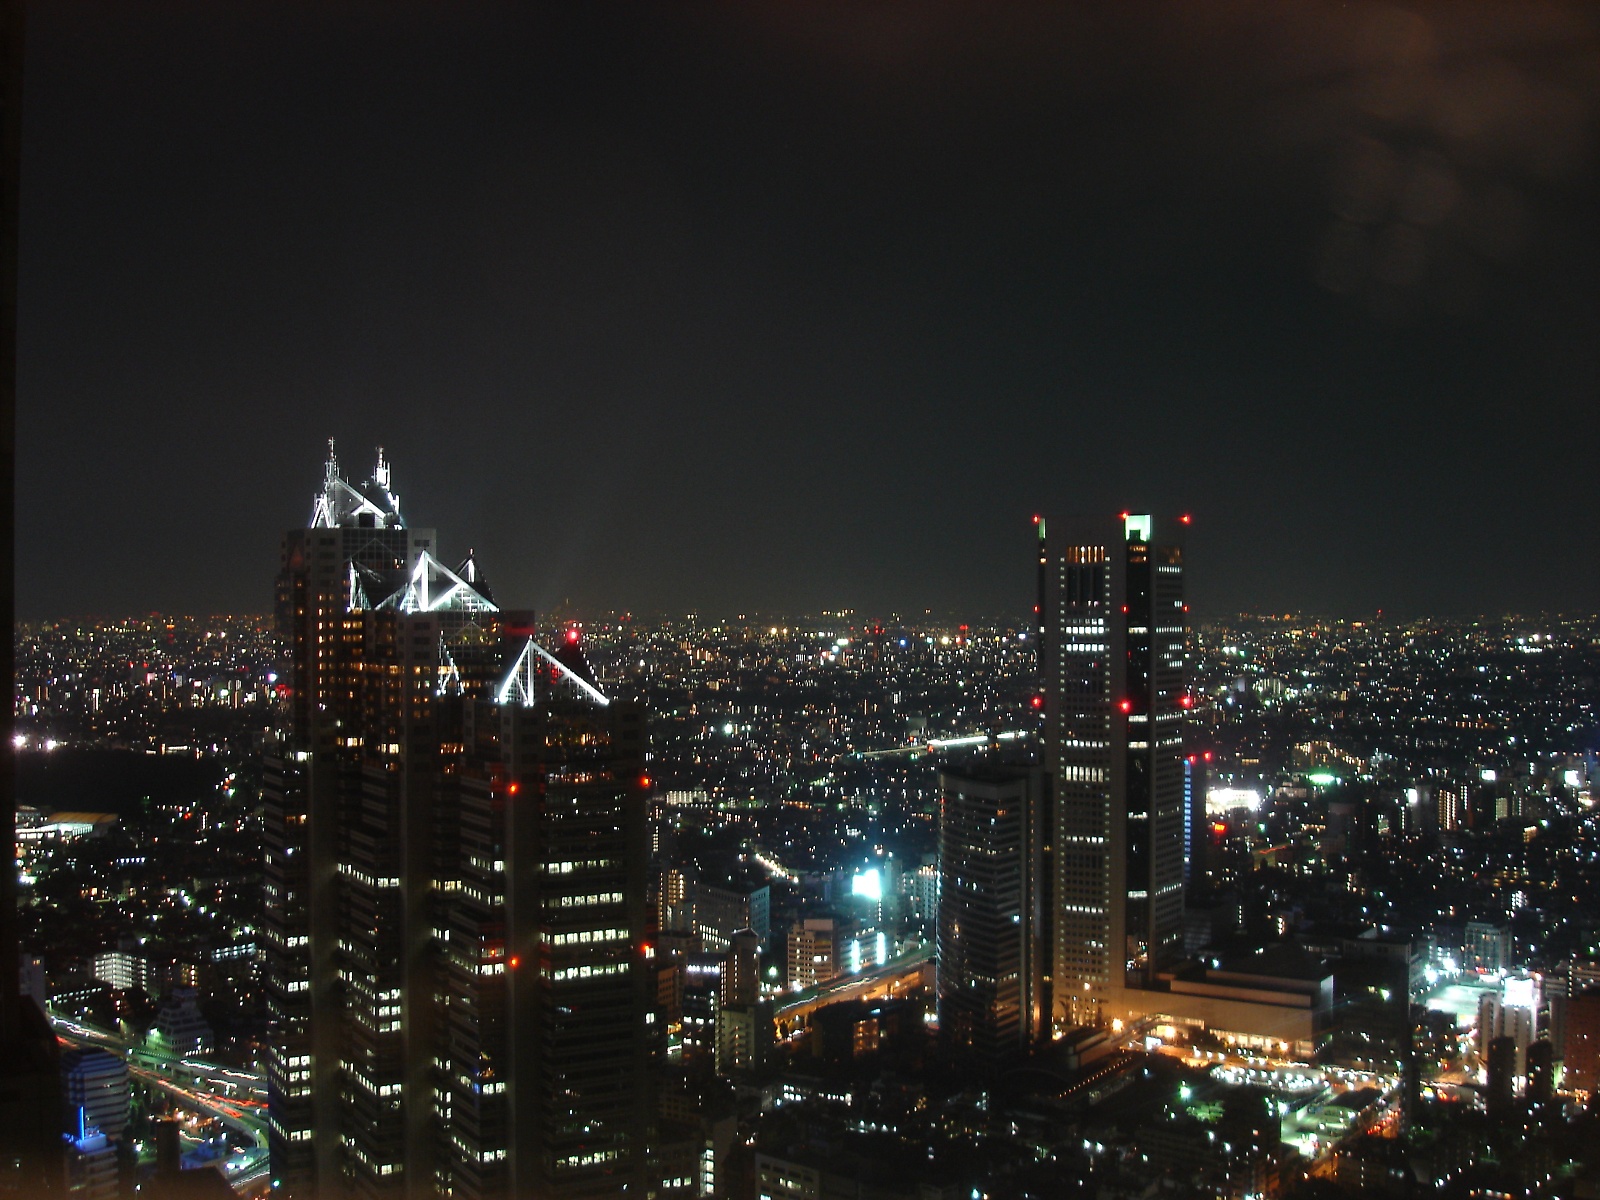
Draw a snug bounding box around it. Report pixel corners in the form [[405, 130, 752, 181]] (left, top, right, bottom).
[[262, 440, 419, 1197]]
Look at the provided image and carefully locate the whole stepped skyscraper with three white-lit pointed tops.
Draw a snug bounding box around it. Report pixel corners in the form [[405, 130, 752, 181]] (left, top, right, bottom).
[[262, 445, 646, 1200]]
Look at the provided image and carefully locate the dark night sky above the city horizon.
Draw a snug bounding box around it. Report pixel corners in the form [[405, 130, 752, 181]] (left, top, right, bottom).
[[16, 0, 1600, 618]]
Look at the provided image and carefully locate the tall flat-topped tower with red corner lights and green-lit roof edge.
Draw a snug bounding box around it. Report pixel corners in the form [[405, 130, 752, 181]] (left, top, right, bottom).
[[1035, 514, 1192, 1026]]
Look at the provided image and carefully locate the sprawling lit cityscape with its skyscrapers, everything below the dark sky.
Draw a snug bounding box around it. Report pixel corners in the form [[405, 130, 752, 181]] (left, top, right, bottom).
[[18, 521, 1600, 1200]]
